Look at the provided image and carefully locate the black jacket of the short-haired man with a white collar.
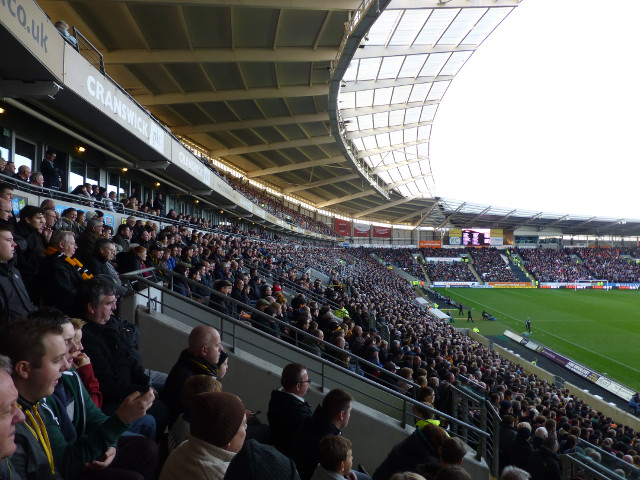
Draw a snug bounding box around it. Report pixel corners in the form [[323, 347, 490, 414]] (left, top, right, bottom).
[[267, 390, 313, 455]]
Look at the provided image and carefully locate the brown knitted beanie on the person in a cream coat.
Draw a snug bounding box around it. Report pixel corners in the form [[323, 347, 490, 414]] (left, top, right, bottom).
[[191, 392, 245, 448]]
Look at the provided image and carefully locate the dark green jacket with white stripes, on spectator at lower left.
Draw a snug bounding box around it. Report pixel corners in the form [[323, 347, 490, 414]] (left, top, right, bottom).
[[42, 368, 129, 479]]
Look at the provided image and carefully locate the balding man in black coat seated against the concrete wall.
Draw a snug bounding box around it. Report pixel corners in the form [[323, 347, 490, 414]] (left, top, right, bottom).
[[162, 325, 222, 424]]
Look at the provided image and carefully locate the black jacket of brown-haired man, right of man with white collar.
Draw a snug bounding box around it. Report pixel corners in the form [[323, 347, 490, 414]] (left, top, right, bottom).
[[290, 405, 340, 480]]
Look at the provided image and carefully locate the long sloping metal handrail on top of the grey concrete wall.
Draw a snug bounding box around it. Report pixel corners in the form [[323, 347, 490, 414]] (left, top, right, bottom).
[[121, 269, 489, 437]]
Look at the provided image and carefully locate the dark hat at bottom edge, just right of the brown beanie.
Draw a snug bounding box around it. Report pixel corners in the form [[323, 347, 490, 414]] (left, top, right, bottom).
[[224, 440, 300, 480]]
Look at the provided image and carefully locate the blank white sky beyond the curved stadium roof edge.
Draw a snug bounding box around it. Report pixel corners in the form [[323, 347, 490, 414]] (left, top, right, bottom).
[[430, 0, 640, 219]]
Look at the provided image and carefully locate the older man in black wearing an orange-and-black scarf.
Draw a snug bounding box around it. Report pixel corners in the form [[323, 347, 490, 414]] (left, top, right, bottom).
[[38, 230, 93, 312]]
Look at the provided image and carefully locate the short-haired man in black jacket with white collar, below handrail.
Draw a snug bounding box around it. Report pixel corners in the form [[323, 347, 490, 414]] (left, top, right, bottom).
[[267, 363, 313, 455]]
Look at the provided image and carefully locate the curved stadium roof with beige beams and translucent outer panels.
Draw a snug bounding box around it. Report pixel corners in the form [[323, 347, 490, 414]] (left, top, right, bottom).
[[31, 0, 640, 235]]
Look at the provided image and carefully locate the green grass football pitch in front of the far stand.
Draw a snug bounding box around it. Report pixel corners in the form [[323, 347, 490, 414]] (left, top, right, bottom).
[[436, 288, 640, 390]]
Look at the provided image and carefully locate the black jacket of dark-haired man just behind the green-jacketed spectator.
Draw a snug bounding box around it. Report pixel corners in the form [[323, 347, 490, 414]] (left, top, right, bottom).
[[82, 317, 149, 413]]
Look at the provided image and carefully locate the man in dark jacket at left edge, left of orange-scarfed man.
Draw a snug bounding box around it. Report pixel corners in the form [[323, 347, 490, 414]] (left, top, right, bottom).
[[0, 223, 37, 325]]
